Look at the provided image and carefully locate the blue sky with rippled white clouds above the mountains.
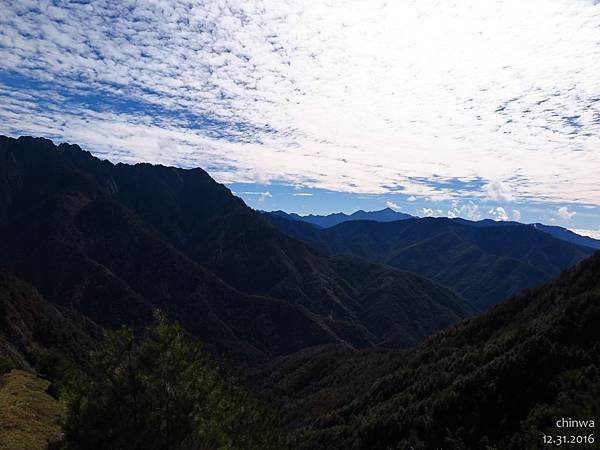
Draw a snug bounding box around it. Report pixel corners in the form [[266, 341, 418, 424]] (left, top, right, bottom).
[[0, 0, 600, 237]]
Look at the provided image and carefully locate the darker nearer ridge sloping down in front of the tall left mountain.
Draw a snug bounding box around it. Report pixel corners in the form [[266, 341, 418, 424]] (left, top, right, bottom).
[[2, 181, 356, 358]]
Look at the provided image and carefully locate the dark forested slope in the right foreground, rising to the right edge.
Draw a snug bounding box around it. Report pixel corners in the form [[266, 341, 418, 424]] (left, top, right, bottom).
[[254, 252, 600, 450]]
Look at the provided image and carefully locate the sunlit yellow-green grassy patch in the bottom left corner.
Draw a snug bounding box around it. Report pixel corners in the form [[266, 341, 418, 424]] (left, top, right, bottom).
[[0, 370, 65, 450]]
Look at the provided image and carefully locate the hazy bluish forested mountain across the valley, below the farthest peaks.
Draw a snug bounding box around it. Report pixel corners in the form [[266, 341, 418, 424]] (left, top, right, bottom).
[[270, 217, 593, 310]]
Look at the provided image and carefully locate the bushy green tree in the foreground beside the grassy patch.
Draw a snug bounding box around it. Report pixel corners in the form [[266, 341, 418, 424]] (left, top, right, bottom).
[[54, 323, 281, 450]]
